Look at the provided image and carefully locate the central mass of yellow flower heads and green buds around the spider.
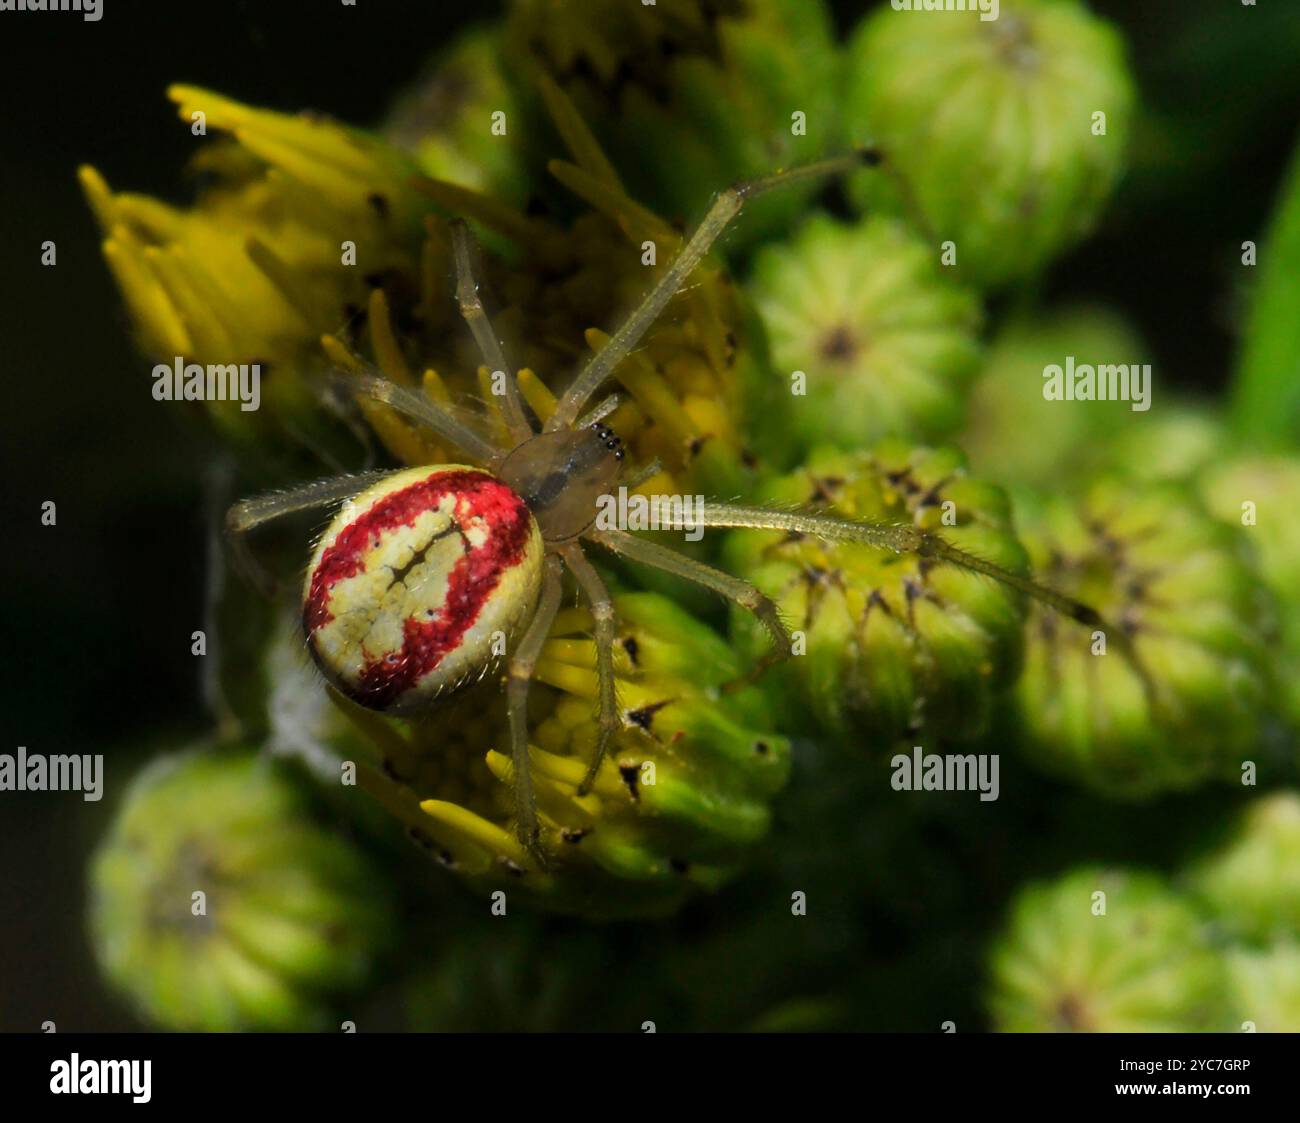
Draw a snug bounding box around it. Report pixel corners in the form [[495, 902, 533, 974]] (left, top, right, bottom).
[[91, 0, 1300, 946]]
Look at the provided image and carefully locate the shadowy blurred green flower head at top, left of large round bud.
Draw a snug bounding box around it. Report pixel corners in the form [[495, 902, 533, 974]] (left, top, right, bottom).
[[507, 0, 841, 252]]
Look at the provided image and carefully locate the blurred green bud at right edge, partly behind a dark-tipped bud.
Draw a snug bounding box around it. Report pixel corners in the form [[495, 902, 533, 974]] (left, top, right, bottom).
[[1200, 456, 1300, 727]]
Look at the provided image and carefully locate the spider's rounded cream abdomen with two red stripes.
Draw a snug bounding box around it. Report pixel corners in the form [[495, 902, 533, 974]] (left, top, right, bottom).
[[303, 464, 542, 714]]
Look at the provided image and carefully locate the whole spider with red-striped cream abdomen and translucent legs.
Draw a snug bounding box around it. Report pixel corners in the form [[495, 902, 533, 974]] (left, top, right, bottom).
[[226, 149, 1101, 860]]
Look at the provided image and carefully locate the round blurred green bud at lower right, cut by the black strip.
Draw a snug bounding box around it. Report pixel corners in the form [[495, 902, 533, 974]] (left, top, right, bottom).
[[989, 868, 1225, 1033]]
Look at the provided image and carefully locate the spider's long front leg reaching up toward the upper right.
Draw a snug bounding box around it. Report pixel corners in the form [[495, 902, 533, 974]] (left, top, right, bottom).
[[546, 148, 880, 430]]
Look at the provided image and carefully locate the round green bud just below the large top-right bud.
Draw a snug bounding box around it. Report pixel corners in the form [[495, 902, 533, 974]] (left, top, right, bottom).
[[748, 214, 980, 463]]
